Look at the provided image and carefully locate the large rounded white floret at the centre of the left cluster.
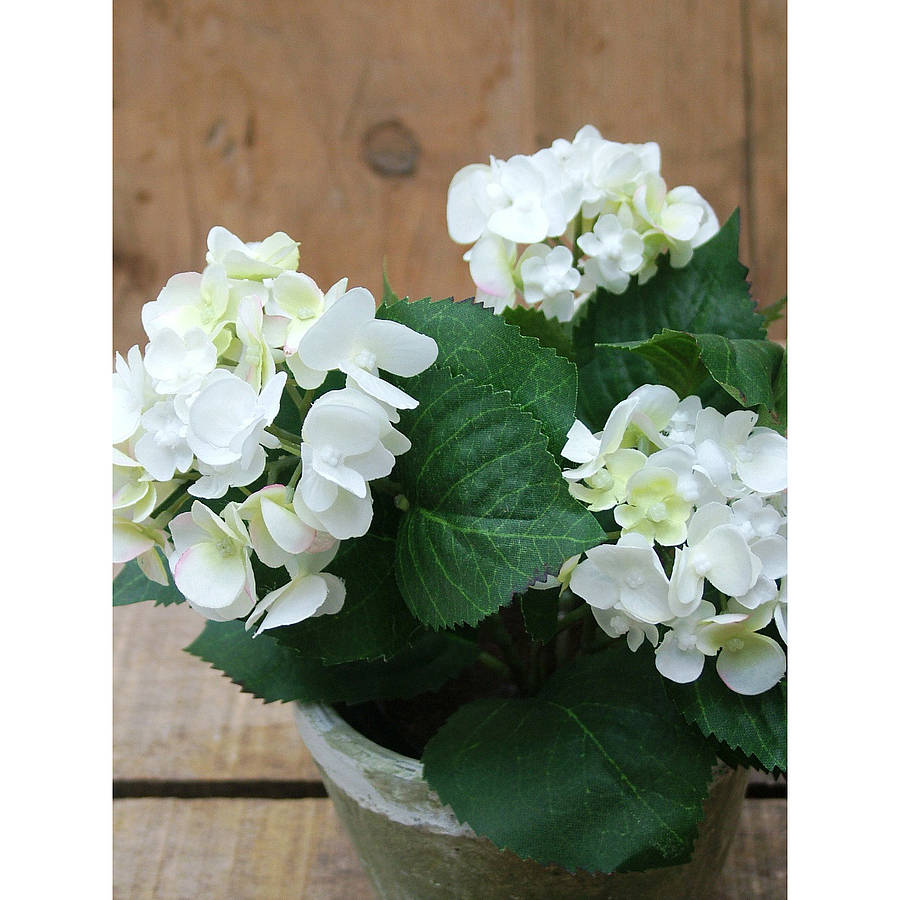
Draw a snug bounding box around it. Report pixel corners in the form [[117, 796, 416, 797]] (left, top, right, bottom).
[[187, 369, 287, 468]]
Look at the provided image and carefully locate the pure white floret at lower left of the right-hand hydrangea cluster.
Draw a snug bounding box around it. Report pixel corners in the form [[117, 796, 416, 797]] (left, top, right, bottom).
[[569, 534, 671, 625]]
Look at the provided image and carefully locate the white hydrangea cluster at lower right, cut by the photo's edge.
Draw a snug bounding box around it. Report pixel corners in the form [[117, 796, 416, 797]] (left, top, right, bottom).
[[560, 385, 787, 695]]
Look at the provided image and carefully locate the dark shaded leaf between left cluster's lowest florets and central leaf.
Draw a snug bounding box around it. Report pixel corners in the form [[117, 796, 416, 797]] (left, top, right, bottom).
[[269, 496, 422, 665]]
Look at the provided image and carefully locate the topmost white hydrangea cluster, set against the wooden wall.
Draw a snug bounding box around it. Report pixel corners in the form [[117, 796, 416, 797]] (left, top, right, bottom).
[[447, 125, 719, 322]]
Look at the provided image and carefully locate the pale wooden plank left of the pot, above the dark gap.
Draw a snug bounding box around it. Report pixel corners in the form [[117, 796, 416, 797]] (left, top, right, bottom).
[[113, 603, 319, 781]]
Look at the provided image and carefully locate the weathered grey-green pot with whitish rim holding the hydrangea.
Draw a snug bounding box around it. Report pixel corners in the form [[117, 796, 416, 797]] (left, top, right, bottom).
[[295, 703, 748, 900]]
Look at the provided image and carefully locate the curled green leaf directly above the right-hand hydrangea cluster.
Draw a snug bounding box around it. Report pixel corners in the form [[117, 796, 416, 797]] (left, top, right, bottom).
[[598, 328, 787, 430]]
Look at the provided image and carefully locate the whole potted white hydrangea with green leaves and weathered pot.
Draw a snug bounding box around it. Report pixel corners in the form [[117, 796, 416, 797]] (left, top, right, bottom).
[[113, 127, 787, 897]]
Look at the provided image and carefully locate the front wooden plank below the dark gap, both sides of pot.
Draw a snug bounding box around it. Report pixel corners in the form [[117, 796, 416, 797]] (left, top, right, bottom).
[[113, 799, 787, 900]]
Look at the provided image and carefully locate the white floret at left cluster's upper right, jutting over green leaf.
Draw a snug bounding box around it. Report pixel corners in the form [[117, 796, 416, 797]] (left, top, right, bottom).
[[295, 288, 438, 409]]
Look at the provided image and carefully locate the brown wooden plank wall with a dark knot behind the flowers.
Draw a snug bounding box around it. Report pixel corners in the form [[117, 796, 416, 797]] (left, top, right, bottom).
[[113, 0, 786, 351]]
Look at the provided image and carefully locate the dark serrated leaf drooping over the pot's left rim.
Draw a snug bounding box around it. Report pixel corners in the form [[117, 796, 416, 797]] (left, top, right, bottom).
[[185, 621, 478, 703]]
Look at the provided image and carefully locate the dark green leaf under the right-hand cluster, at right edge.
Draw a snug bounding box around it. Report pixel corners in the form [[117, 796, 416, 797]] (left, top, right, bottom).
[[666, 666, 787, 772]]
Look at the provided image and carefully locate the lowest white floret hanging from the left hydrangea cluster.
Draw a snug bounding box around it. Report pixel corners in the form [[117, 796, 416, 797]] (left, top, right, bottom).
[[246, 544, 347, 637]]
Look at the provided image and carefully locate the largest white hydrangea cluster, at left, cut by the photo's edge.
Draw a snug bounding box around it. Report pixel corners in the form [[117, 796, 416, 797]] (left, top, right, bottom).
[[113, 227, 438, 634]]
